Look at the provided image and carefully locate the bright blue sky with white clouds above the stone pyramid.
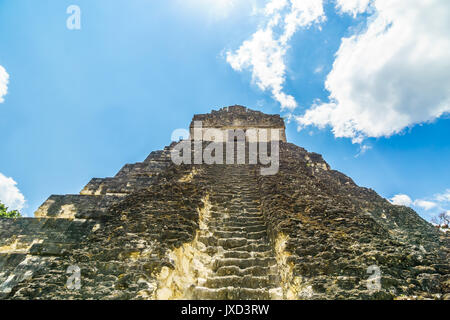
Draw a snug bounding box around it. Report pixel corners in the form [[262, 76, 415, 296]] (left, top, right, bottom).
[[0, 0, 450, 219]]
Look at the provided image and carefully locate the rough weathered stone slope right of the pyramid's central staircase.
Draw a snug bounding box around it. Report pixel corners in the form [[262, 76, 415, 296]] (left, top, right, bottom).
[[259, 143, 450, 299]]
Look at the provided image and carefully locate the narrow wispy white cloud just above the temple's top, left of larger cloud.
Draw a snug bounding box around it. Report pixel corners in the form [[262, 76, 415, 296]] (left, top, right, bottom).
[[226, 0, 325, 110]]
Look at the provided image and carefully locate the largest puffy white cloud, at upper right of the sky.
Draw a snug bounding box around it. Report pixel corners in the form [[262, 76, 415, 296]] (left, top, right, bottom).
[[296, 0, 450, 143]]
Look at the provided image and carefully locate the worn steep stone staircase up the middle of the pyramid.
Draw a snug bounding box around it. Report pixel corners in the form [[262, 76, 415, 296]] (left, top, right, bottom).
[[194, 165, 282, 300]]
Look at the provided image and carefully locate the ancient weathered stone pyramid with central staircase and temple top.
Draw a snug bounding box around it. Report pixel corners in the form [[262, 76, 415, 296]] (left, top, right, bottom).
[[0, 106, 450, 299]]
